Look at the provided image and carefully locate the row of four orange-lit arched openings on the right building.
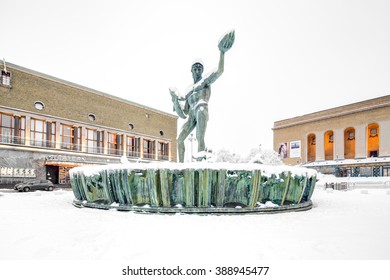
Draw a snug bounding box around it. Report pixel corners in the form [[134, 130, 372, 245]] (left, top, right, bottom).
[[307, 123, 379, 162]]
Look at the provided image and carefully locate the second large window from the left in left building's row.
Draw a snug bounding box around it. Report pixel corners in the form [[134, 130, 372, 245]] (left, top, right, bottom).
[[30, 119, 56, 148]]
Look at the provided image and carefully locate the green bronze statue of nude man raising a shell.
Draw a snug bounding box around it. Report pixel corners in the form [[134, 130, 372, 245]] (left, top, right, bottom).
[[169, 30, 235, 162]]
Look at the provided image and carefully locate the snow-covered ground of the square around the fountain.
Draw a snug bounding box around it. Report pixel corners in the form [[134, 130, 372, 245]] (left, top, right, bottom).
[[0, 178, 390, 279]]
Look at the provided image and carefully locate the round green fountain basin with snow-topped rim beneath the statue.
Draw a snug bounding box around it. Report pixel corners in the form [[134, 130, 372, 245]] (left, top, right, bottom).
[[70, 162, 317, 214]]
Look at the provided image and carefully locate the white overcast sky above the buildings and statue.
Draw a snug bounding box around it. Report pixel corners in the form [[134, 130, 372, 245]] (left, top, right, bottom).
[[0, 0, 390, 155]]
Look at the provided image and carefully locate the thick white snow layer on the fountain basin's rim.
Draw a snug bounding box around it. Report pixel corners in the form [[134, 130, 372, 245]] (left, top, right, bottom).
[[69, 162, 317, 178]]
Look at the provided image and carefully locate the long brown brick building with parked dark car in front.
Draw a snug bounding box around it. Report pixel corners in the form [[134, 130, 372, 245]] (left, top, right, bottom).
[[0, 63, 177, 187]]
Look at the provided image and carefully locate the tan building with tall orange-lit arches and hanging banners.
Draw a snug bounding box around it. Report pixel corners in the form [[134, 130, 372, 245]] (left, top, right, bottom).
[[273, 95, 390, 176]]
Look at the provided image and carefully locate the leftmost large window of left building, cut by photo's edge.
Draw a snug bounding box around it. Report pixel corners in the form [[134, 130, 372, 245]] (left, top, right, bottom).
[[0, 113, 26, 144]]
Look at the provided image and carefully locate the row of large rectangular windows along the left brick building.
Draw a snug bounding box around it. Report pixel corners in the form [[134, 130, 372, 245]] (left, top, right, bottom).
[[0, 112, 169, 160]]
